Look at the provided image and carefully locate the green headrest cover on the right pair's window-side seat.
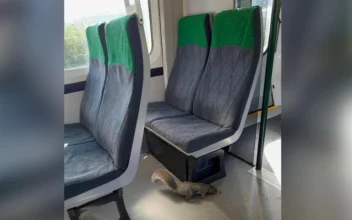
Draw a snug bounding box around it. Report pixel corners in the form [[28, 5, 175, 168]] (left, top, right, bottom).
[[178, 14, 209, 47]]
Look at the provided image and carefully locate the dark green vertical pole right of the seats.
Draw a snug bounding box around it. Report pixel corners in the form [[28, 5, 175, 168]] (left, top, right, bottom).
[[256, 0, 281, 170]]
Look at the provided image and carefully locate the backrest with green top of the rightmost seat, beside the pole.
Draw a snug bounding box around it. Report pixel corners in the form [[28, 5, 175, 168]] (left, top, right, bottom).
[[193, 7, 262, 130]]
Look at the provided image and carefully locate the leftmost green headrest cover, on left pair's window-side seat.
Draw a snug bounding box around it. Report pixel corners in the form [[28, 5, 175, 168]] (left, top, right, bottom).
[[86, 24, 105, 63]]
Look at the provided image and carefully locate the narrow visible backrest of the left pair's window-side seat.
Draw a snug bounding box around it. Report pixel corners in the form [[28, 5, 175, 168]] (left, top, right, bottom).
[[80, 23, 107, 133]]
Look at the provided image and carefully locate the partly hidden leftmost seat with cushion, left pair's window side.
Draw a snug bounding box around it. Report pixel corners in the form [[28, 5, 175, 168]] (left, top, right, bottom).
[[64, 23, 107, 145]]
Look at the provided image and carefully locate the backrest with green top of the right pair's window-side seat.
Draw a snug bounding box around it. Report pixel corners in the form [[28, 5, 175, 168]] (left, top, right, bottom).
[[165, 14, 211, 112]]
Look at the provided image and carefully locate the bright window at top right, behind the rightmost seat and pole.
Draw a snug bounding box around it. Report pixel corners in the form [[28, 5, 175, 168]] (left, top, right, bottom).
[[236, 0, 273, 51]]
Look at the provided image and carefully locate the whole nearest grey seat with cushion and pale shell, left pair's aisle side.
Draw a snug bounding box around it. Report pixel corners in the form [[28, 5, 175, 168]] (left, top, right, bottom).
[[64, 15, 150, 209]]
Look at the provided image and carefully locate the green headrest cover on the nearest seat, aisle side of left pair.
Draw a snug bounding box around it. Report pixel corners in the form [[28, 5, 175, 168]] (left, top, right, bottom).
[[105, 15, 135, 72]]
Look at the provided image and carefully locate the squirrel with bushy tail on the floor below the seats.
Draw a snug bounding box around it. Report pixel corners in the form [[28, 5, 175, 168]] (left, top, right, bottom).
[[152, 170, 217, 201]]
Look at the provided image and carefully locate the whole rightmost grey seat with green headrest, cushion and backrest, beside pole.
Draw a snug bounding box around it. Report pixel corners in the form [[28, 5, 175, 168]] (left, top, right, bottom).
[[149, 7, 262, 156]]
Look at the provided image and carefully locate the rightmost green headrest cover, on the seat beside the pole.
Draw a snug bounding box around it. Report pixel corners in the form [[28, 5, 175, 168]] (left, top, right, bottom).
[[211, 6, 259, 49]]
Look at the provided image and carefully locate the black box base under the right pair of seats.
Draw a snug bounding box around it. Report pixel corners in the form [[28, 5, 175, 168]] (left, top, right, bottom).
[[144, 129, 226, 183]]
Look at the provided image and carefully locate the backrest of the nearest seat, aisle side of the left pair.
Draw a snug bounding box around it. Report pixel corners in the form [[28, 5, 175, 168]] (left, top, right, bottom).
[[94, 15, 145, 169]]
